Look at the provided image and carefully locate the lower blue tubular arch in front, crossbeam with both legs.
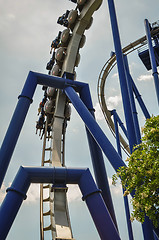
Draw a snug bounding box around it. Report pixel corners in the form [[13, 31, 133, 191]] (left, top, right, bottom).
[[0, 167, 120, 240]]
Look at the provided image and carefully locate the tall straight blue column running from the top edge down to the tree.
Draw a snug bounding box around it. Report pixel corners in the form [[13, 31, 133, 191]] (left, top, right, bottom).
[[108, 0, 137, 152]]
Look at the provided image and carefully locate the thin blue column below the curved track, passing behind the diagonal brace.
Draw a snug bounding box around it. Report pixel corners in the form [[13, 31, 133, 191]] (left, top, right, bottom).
[[112, 110, 134, 240]]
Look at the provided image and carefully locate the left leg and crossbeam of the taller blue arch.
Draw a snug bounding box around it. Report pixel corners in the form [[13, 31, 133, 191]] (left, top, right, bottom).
[[0, 72, 85, 187]]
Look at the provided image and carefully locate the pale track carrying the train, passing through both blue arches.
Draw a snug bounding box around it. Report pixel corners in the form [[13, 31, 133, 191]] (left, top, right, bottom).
[[40, 0, 102, 240]]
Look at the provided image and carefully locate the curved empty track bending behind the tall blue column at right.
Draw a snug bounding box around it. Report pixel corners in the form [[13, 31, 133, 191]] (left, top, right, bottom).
[[97, 28, 159, 155]]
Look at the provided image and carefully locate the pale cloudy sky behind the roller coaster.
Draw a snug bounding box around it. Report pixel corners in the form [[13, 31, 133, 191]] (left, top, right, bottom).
[[0, 0, 159, 240]]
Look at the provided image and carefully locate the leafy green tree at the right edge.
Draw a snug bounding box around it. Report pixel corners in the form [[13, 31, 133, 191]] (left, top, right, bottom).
[[113, 116, 159, 227]]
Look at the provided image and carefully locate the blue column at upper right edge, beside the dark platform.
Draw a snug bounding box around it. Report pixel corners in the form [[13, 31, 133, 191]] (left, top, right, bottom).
[[144, 19, 159, 104]]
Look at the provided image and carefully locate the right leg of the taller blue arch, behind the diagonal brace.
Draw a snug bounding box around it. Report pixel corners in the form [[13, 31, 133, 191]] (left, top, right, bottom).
[[79, 84, 118, 228]]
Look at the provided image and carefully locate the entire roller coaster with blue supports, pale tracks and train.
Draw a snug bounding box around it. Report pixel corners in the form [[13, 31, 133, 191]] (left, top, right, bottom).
[[0, 0, 159, 240]]
